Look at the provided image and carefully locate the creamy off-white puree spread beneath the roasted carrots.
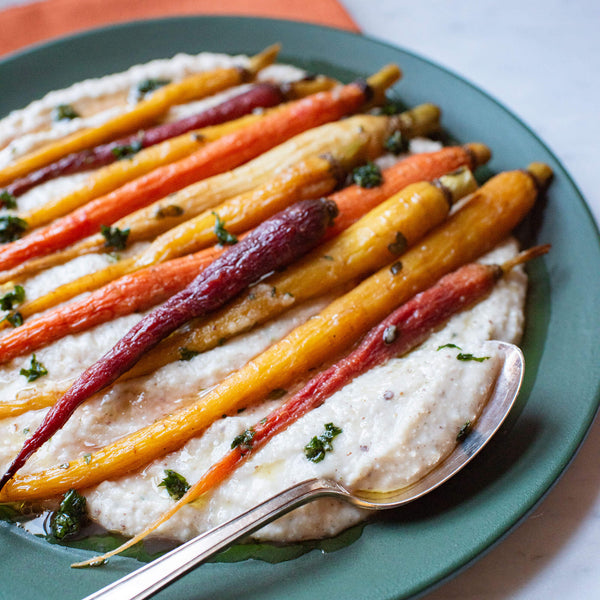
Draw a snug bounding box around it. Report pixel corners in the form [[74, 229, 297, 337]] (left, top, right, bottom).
[[0, 53, 526, 540]]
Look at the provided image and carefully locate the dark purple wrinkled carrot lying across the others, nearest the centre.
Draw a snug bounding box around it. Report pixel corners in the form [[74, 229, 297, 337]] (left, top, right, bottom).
[[0, 200, 337, 489]]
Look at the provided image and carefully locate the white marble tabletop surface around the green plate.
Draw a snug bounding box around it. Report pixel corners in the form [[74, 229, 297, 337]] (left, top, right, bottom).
[[0, 0, 600, 600]]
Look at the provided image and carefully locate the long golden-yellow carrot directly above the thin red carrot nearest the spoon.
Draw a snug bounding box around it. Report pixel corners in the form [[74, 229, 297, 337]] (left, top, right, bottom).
[[0, 163, 552, 501]]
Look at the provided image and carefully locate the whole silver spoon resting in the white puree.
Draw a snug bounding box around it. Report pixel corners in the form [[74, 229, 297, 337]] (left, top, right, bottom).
[[84, 342, 524, 600]]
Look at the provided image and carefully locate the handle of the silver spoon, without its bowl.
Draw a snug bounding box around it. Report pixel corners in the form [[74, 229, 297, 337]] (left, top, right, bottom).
[[84, 479, 344, 600]]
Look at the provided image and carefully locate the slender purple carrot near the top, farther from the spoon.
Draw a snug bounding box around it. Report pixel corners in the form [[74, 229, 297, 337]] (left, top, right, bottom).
[[4, 83, 284, 198]]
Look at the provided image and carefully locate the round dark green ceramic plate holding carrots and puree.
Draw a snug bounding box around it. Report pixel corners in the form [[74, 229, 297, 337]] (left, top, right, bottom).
[[0, 17, 600, 600]]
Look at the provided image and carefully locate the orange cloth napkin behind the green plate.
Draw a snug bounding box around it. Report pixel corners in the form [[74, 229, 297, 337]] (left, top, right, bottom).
[[0, 0, 359, 56]]
